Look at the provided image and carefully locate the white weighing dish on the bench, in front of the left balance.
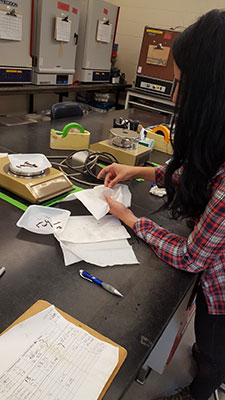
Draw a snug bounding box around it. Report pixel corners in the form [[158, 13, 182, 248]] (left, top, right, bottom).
[[16, 205, 71, 235]]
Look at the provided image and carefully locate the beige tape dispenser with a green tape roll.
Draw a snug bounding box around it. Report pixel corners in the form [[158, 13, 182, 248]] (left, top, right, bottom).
[[50, 122, 90, 150]]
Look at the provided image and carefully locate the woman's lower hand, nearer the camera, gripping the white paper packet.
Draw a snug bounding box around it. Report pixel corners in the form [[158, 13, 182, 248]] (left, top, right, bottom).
[[105, 195, 138, 228]]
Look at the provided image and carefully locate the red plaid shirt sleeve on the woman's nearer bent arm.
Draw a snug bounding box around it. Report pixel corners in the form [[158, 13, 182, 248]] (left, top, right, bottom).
[[133, 180, 225, 273]]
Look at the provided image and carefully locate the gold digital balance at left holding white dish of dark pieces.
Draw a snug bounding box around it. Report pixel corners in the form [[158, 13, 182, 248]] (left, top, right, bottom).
[[0, 154, 73, 203]]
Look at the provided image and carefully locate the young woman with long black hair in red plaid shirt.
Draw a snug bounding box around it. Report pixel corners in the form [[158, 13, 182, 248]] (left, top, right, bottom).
[[96, 10, 225, 400]]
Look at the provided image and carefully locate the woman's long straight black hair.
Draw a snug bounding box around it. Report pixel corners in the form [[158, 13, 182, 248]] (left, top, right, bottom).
[[165, 10, 225, 219]]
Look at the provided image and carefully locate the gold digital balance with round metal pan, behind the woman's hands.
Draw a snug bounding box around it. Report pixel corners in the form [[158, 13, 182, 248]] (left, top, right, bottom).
[[90, 128, 152, 165]]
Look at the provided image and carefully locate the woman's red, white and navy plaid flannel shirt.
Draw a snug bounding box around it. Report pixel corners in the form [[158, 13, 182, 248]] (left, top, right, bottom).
[[133, 163, 225, 315]]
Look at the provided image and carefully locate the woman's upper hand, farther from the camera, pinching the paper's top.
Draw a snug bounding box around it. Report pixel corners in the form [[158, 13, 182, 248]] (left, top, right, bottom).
[[97, 163, 137, 188]]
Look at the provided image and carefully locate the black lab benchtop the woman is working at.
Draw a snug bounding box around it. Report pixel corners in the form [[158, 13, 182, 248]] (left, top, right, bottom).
[[0, 109, 195, 400]]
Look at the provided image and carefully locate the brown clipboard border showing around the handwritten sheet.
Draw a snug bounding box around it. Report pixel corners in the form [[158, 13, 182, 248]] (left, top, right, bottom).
[[1, 300, 127, 400]]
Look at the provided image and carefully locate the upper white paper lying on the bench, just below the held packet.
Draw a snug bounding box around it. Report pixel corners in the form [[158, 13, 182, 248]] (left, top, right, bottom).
[[56, 215, 130, 243]]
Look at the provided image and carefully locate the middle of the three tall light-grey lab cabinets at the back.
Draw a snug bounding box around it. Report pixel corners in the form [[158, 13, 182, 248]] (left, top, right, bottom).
[[32, 0, 80, 85]]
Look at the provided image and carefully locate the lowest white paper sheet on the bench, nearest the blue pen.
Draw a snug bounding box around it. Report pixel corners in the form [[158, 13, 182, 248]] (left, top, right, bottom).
[[60, 239, 139, 267]]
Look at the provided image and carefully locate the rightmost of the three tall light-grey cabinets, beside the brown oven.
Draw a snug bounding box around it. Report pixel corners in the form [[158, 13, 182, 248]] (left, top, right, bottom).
[[75, 0, 119, 82]]
